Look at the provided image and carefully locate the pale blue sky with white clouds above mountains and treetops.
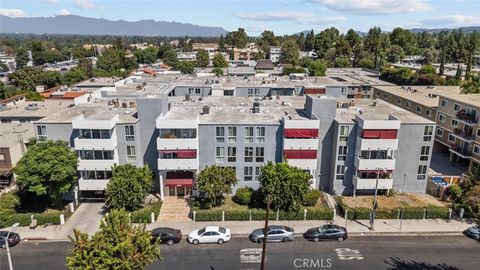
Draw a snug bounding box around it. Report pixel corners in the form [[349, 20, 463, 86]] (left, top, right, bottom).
[[0, 0, 480, 35]]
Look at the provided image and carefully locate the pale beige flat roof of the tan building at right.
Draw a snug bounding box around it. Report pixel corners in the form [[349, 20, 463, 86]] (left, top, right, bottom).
[[375, 85, 460, 108]]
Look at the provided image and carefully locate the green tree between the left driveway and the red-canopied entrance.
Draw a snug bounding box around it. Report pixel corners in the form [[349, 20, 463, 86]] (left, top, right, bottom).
[[105, 164, 153, 211]]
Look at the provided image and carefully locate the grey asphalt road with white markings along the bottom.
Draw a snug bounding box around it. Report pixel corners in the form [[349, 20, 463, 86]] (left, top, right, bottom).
[[0, 236, 480, 270]]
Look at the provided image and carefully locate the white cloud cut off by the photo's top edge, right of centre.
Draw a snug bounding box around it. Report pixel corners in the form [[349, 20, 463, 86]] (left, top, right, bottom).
[[306, 0, 433, 15]]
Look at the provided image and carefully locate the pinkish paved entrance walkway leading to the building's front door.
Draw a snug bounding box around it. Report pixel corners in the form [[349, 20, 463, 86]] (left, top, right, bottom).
[[157, 196, 190, 223]]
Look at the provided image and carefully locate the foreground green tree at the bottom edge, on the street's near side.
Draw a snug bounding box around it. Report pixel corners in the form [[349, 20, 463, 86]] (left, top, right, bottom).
[[67, 210, 160, 270]]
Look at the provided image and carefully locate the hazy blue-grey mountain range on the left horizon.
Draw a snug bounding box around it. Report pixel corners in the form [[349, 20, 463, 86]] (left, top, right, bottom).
[[0, 15, 227, 37]]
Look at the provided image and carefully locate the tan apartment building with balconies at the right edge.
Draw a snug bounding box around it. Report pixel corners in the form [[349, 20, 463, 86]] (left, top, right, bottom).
[[374, 86, 480, 171]]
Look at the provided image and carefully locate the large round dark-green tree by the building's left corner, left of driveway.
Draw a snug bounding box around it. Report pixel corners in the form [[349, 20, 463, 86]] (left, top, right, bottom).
[[15, 141, 77, 205]]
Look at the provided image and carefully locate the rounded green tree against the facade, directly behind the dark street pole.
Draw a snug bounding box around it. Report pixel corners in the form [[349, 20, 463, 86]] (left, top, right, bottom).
[[259, 161, 311, 212]]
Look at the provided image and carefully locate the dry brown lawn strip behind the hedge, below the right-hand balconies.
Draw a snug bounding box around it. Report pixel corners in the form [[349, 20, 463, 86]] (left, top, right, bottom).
[[341, 193, 448, 209]]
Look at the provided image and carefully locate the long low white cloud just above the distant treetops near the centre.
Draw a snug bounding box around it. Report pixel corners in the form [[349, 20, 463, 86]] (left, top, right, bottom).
[[236, 10, 347, 24]]
